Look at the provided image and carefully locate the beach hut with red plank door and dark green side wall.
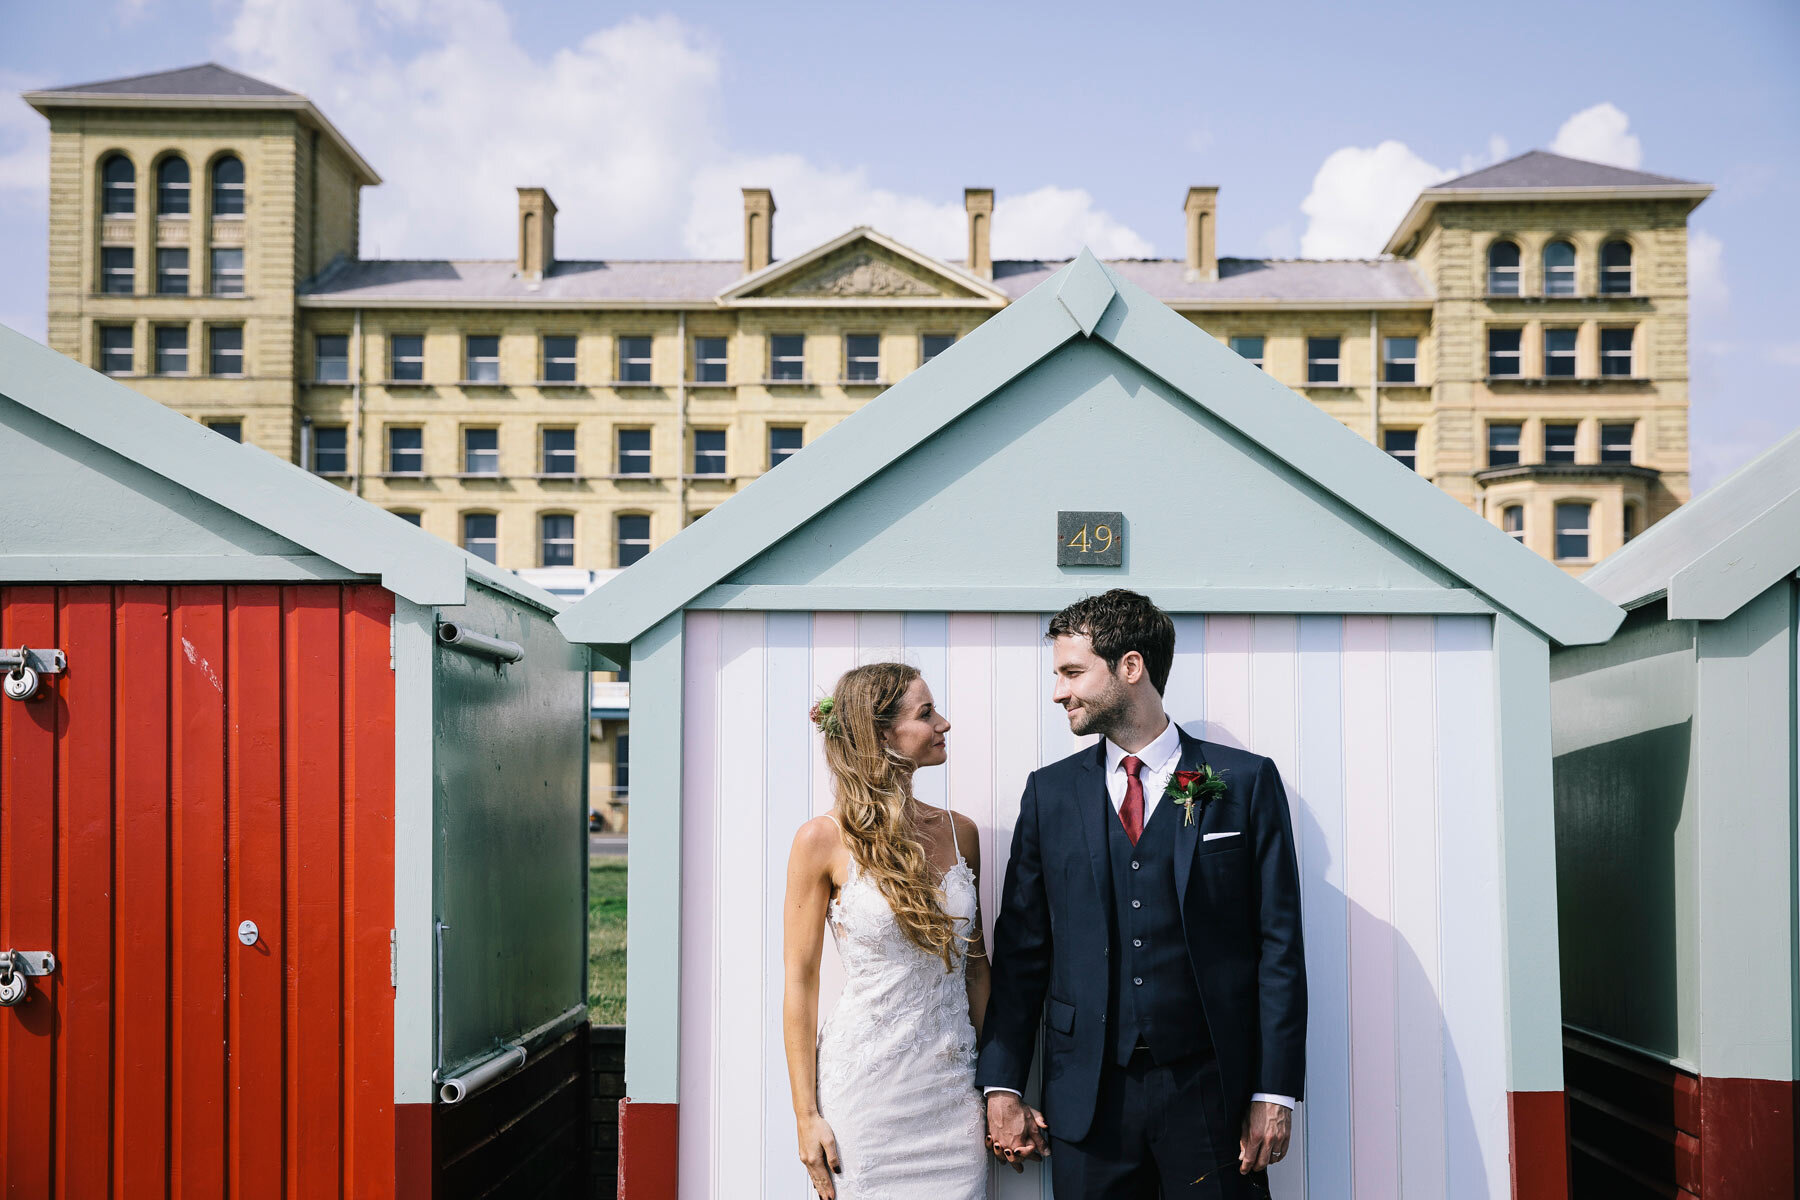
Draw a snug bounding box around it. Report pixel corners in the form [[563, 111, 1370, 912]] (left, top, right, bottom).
[[0, 329, 589, 1200]]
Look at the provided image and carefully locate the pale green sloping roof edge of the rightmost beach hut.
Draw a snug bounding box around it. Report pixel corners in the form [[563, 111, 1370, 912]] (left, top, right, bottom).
[[1582, 430, 1800, 621]]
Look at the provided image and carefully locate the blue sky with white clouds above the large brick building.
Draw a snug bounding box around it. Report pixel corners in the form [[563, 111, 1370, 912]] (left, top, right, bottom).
[[0, 0, 1800, 488]]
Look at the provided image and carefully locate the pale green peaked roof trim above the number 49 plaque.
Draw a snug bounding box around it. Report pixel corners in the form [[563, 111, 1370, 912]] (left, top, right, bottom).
[[558, 250, 1624, 648]]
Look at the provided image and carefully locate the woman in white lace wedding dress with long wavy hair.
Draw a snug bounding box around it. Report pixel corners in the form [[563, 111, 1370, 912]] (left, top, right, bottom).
[[781, 662, 1029, 1200]]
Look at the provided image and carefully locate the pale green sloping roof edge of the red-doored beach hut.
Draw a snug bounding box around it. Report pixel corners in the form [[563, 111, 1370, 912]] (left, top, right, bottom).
[[0, 326, 563, 613]]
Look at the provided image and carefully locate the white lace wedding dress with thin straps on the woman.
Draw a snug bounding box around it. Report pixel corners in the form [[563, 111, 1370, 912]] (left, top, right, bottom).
[[819, 822, 988, 1200]]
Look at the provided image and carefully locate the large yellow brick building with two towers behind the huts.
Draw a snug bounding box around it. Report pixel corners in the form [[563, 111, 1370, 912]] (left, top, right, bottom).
[[25, 65, 1712, 827]]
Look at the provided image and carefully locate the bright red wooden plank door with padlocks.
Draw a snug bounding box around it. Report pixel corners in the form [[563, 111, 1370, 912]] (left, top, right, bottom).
[[0, 585, 394, 1200]]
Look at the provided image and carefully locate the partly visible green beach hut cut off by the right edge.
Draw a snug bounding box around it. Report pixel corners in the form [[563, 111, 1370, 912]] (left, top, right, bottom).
[[1550, 434, 1800, 1200]]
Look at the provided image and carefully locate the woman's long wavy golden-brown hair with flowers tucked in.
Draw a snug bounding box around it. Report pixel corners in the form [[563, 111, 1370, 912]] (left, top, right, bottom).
[[814, 662, 970, 972]]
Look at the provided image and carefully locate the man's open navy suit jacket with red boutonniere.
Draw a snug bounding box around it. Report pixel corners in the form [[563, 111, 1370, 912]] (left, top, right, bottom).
[[976, 732, 1307, 1141]]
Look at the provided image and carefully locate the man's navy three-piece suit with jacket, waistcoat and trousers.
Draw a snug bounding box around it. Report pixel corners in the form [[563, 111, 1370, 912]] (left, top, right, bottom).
[[976, 732, 1307, 1195]]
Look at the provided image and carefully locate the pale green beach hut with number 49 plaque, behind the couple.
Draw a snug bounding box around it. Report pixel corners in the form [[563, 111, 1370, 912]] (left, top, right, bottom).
[[558, 252, 1622, 1200]]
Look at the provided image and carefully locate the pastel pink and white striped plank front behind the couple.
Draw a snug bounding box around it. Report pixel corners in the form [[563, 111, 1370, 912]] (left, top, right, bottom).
[[680, 612, 1510, 1200]]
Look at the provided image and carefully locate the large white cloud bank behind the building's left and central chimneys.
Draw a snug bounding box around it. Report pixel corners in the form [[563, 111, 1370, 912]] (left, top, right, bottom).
[[210, 0, 1150, 259]]
